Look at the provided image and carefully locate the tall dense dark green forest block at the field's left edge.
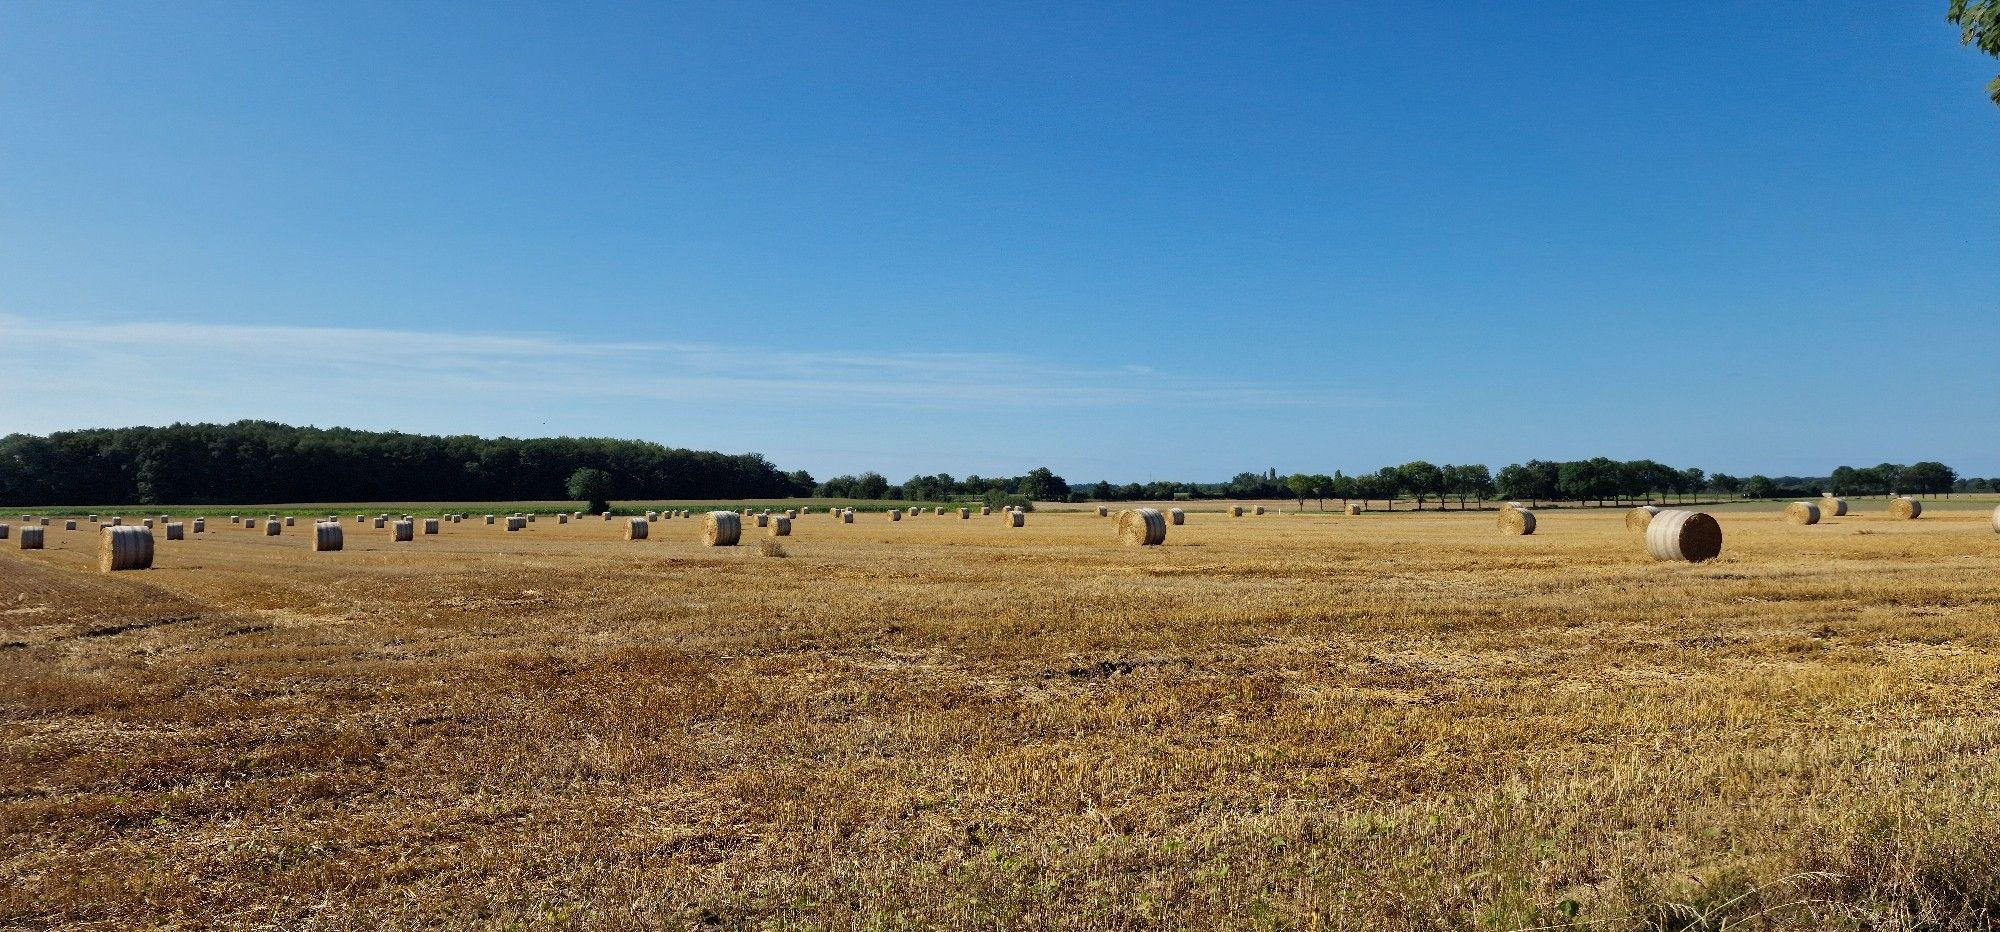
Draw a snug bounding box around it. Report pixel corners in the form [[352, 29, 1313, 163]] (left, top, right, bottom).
[[0, 420, 812, 506]]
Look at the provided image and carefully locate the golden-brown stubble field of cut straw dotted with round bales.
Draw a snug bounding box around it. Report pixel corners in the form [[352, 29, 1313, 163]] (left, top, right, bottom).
[[0, 512, 2000, 930]]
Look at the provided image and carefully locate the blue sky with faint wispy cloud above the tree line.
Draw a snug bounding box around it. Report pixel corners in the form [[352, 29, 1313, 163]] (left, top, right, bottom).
[[0, 0, 2000, 482]]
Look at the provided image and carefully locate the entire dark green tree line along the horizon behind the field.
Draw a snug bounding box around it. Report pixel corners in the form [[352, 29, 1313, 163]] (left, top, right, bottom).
[[0, 420, 2000, 508]]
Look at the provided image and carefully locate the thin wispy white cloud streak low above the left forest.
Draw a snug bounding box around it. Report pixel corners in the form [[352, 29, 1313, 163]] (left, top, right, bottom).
[[0, 316, 1376, 426]]
